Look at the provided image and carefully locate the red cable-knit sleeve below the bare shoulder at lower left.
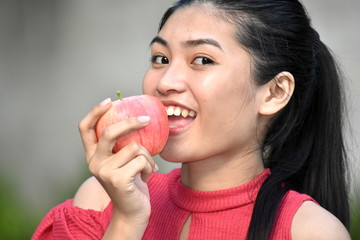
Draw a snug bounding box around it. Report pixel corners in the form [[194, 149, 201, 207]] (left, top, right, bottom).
[[31, 199, 112, 240]]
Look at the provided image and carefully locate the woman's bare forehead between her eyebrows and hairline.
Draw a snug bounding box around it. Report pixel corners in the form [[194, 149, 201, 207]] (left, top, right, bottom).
[[158, 5, 236, 46]]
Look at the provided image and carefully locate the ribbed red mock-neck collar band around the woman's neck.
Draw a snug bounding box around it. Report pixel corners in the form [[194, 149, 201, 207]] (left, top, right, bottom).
[[168, 169, 270, 213]]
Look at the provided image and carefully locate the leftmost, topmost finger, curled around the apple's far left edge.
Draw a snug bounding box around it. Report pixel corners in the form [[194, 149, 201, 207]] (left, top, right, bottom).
[[78, 98, 112, 155]]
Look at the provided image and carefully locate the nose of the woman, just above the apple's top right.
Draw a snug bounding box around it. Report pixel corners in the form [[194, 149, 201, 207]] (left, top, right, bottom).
[[157, 63, 187, 95]]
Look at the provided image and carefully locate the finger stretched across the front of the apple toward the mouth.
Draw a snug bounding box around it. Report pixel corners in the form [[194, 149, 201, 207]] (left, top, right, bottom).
[[97, 117, 149, 157]]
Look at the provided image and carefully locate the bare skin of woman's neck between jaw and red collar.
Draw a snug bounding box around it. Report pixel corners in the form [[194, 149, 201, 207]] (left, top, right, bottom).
[[181, 151, 264, 191]]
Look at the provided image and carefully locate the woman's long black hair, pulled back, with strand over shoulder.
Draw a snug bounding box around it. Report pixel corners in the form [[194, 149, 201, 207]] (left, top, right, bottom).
[[159, 0, 349, 240]]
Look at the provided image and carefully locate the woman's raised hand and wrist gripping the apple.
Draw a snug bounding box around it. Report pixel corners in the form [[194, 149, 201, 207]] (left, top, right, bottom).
[[79, 100, 157, 238]]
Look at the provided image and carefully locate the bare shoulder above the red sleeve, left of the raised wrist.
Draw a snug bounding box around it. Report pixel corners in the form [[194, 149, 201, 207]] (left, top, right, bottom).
[[73, 177, 110, 211]]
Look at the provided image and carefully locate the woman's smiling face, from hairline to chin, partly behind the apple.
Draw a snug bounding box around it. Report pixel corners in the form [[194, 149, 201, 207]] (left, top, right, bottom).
[[143, 6, 260, 162]]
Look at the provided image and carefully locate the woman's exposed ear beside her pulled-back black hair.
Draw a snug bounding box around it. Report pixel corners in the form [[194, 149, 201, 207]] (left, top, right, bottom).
[[259, 72, 295, 115]]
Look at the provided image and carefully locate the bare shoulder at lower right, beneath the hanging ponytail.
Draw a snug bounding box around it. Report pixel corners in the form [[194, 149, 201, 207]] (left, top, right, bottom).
[[291, 201, 351, 240]]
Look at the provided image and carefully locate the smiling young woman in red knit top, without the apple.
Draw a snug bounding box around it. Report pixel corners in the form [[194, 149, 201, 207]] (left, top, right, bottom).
[[33, 0, 350, 240]]
